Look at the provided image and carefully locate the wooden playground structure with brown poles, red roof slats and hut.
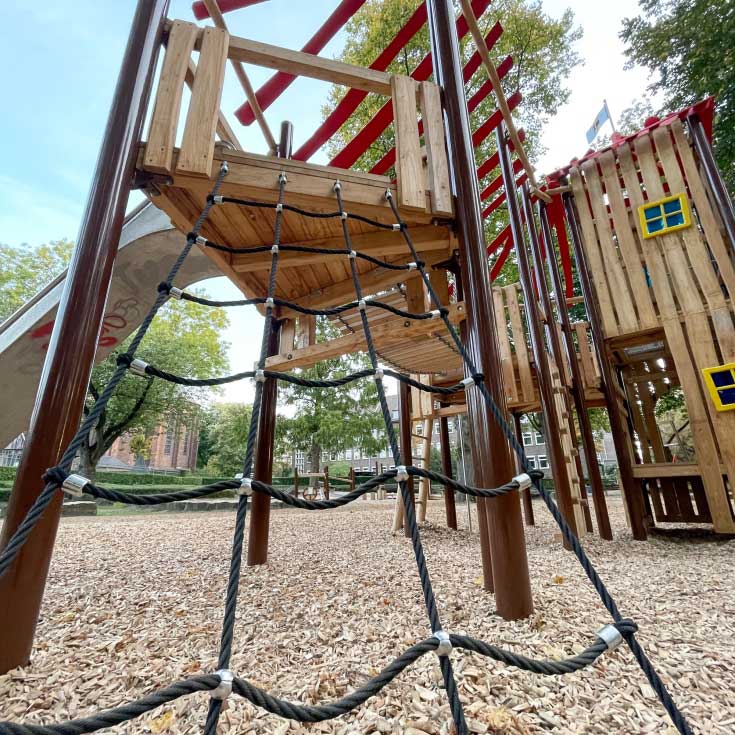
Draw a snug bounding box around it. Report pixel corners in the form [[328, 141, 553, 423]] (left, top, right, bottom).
[[0, 0, 735, 733]]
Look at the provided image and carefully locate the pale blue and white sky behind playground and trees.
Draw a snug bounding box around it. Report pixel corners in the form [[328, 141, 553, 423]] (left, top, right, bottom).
[[0, 0, 660, 400]]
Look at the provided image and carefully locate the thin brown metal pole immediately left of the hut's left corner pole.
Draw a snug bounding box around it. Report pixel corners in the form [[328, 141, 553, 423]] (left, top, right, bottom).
[[538, 202, 613, 541]]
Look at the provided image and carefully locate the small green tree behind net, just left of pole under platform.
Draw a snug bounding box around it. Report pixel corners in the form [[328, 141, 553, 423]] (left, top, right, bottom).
[[200, 403, 253, 477]]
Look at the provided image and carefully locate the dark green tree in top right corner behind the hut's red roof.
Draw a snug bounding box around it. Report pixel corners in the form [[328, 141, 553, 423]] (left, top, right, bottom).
[[620, 0, 735, 193]]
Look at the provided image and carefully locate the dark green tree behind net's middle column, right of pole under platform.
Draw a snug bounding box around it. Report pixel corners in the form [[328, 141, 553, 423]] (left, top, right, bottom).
[[277, 319, 387, 480]]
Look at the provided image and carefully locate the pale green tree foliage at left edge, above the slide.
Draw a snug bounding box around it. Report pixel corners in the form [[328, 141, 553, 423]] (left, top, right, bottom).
[[0, 240, 74, 322]]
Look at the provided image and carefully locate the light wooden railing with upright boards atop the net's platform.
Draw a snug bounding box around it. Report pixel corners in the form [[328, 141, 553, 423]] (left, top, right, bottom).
[[143, 20, 452, 216]]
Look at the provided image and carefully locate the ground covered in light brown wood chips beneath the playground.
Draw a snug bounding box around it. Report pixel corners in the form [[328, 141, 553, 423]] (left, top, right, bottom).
[[0, 498, 735, 735]]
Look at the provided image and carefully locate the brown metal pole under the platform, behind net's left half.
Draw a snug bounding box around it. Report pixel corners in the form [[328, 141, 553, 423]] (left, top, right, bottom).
[[248, 319, 282, 567]]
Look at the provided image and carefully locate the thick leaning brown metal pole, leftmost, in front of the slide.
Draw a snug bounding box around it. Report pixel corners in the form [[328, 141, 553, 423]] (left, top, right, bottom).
[[0, 0, 168, 673]]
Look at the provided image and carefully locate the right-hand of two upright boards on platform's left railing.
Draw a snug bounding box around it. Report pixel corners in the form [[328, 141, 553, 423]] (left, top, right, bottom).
[[176, 28, 229, 176]]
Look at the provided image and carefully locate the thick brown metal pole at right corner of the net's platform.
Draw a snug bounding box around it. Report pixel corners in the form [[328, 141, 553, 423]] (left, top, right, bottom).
[[426, 0, 533, 620]]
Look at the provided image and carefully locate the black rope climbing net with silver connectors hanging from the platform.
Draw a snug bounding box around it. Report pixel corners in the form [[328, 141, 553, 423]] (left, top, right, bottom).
[[0, 163, 692, 735]]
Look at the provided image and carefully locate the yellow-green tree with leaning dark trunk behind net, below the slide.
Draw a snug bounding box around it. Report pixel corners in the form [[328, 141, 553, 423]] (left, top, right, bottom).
[[80, 291, 229, 479]]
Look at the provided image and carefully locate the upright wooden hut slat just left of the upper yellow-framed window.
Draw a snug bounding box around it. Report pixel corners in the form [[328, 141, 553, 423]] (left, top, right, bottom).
[[600, 151, 659, 329]]
